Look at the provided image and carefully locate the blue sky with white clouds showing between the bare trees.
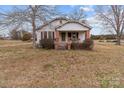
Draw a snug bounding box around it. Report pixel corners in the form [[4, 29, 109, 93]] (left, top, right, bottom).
[[0, 5, 104, 35]]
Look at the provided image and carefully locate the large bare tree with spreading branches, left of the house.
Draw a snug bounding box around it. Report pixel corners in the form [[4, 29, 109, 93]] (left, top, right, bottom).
[[0, 5, 56, 48]]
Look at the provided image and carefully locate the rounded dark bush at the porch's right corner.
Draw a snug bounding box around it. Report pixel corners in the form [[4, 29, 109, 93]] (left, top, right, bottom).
[[82, 39, 94, 50]]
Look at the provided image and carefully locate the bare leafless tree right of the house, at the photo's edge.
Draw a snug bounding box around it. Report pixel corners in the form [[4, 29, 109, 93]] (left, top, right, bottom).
[[96, 5, 124, 45]]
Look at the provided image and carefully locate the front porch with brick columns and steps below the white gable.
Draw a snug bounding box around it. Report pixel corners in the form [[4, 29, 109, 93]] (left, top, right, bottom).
[[54, 31, 90, 49]]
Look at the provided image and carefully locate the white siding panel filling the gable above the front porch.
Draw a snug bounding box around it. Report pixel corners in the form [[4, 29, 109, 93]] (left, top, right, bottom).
[[57, 23, 89, 31]]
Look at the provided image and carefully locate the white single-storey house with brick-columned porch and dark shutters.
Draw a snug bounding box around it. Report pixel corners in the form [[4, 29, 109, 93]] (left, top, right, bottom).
[[36, 18, 91, 48]]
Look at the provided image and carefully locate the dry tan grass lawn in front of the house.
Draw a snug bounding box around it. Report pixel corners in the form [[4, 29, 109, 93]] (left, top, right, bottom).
[[0, 40, 124, 87]]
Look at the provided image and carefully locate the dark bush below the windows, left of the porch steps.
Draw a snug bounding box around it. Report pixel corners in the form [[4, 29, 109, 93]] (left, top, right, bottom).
[[40, 39, 54, 49]]
